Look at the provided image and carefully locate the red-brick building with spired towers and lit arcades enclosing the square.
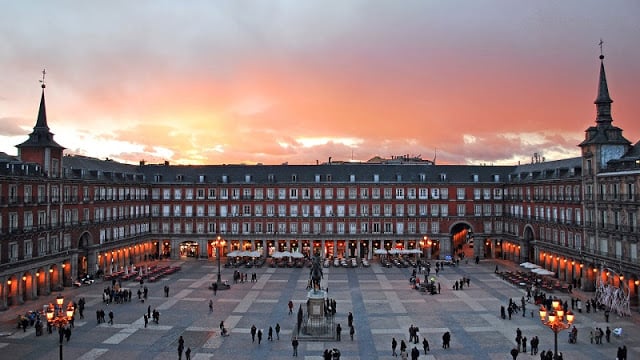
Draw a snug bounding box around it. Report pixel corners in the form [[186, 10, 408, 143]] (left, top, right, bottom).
[[0, 54, 640, 308]]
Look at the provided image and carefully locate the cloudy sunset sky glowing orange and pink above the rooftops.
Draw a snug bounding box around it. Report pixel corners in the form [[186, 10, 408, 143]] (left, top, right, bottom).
[[0, 0, 640, 165]]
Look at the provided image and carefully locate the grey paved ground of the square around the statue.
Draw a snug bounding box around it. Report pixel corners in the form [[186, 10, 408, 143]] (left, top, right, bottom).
[[0, 260, 640, 360]]
